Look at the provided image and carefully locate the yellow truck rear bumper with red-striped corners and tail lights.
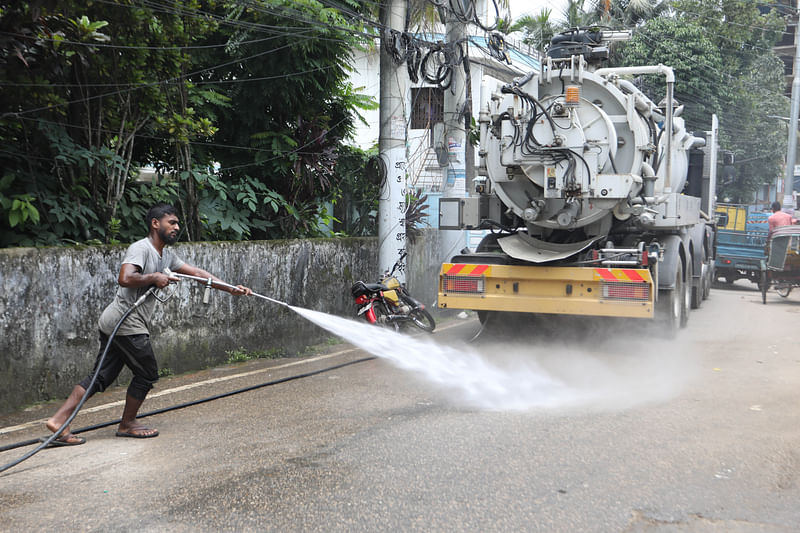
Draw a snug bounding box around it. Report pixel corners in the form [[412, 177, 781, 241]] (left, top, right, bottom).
[[438, 263, 655, 318]]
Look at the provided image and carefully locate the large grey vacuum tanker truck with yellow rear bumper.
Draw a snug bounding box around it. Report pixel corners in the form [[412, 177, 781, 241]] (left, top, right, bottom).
[[438, 30, 716, 330]]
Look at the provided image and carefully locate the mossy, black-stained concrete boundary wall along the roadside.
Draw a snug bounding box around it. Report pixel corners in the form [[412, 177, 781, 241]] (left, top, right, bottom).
[[0, 230, 439, 414]]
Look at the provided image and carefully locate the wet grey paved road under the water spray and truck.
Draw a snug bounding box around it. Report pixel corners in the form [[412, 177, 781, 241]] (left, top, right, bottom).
[[0, 282, 800, 532]]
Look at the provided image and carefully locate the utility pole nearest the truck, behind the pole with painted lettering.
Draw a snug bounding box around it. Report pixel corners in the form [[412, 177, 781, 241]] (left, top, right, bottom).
[[441, 0, 472, 261]]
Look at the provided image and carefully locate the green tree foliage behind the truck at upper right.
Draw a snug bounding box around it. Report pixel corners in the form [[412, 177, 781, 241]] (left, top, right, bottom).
[[618, 4, 788, 202]]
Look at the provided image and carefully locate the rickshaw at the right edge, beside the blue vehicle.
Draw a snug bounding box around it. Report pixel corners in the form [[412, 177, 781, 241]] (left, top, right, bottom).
[[761, 226, 800, 304]]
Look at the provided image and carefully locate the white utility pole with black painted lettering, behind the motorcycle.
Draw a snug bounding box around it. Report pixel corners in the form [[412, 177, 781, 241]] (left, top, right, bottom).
[[378, 0, 409, 283]]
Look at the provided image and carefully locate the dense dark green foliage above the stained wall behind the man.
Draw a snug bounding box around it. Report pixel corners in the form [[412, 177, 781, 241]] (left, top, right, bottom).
[[0, 0, 377, 246]]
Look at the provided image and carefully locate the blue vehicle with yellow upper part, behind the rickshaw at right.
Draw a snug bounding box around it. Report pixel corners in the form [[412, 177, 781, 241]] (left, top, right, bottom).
[[714, 204, 772, 285]]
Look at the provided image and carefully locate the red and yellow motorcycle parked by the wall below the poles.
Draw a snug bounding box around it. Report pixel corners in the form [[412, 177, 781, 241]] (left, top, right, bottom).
[[350, 254, 436, 333]]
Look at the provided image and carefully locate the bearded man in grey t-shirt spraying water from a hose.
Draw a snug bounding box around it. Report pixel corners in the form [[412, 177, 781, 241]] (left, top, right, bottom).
[[46, 204, 252, 446]]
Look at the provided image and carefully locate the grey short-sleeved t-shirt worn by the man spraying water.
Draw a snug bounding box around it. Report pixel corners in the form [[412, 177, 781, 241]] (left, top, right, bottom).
[[98, 237, 184, 335]]
